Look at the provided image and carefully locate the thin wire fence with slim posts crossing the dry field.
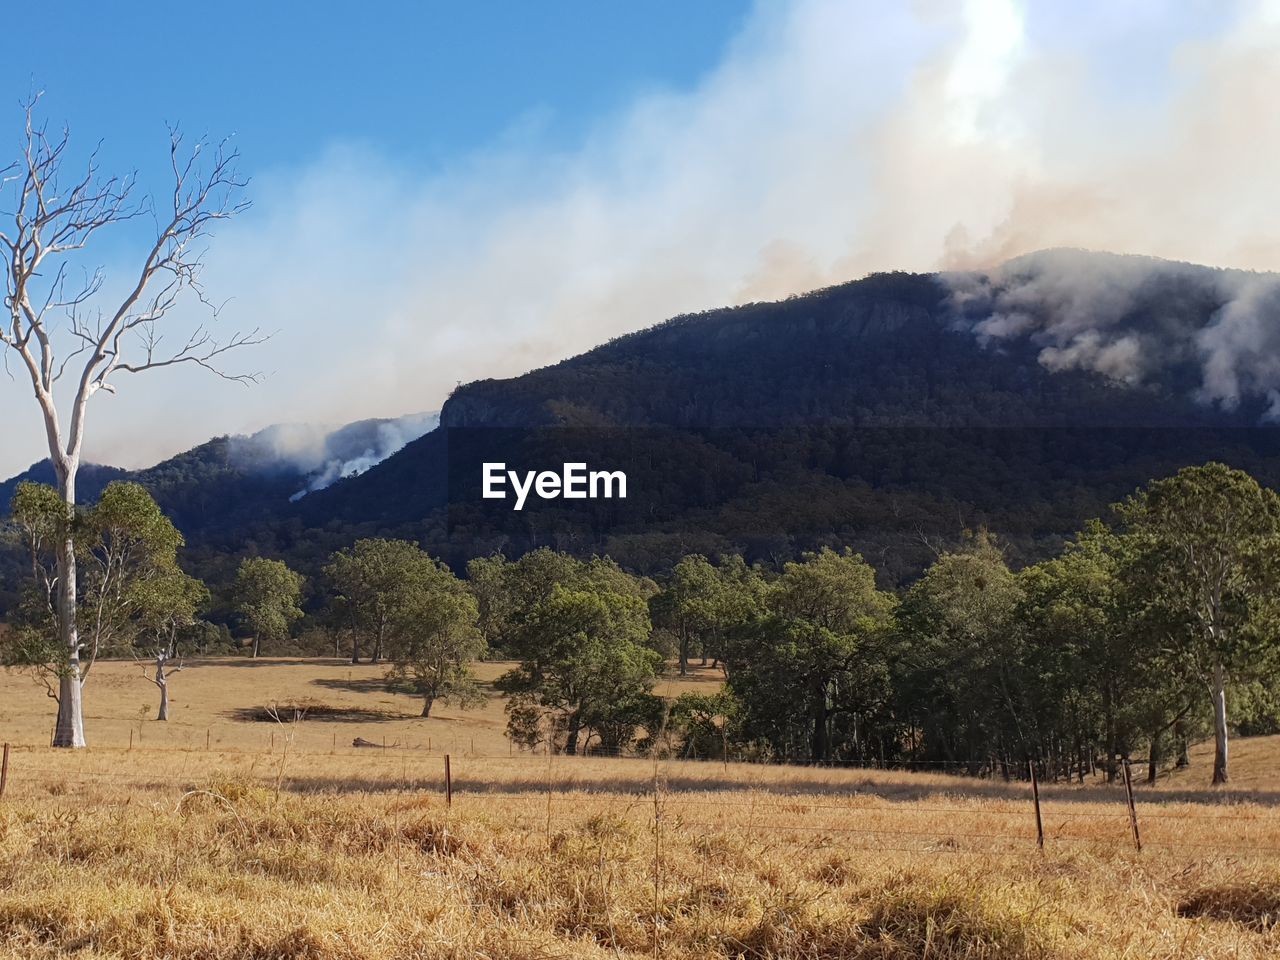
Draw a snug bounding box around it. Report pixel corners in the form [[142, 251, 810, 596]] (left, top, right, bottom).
[[0, 736, 1280, 858]]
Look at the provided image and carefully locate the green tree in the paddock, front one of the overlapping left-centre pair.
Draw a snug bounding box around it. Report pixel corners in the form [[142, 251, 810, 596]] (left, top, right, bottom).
[[388, 562, 485, 717]]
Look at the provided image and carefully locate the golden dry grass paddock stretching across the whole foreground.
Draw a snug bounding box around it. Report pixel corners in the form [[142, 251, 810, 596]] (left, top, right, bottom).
[[0, 660, 1280, 960]]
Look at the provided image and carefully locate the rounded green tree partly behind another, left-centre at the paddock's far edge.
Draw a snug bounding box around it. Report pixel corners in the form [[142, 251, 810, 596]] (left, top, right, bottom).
[[324, 539, 435, 663]]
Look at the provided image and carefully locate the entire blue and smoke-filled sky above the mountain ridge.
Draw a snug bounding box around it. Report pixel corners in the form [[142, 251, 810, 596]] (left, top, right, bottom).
[[0, 0, 1280, 475]]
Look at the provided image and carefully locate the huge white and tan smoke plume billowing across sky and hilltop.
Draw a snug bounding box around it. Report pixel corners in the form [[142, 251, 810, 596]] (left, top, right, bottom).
[[0, 0, 1280, 481]]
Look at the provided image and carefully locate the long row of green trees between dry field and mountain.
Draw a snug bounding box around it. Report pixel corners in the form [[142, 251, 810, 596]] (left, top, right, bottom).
[[4, 463, 1280, 782]]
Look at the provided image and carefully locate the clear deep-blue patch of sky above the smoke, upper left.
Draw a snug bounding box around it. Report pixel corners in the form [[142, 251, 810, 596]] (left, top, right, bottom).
[[0, 0, 750, 181]]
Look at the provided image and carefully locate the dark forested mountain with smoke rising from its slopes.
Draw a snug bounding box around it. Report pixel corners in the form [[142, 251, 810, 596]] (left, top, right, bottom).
[[2, 250, 1280, 601]]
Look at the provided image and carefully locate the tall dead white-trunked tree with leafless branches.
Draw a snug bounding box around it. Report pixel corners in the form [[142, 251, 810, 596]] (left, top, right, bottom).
[[0, 97, 261, 748]]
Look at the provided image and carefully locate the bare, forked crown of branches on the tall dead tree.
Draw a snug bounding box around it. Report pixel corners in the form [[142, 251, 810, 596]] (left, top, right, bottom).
[[0, 95, 254, 474]]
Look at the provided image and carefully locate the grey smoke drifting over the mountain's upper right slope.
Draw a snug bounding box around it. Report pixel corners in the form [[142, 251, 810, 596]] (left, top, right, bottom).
[[946, 250, 1280, 419]]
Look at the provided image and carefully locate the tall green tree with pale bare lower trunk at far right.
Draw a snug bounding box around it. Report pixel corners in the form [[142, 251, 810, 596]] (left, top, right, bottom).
[[1117, 463, 1280, 785]]
